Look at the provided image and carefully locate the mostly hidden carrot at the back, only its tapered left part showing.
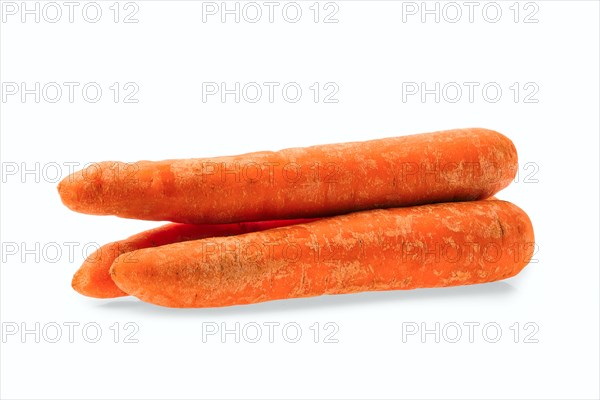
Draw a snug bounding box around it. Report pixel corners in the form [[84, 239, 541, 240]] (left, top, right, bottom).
[[71, 219, 314, 298]]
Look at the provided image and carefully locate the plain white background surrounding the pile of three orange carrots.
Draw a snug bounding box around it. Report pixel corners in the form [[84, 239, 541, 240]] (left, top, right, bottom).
[[0, 1, 600, 399]]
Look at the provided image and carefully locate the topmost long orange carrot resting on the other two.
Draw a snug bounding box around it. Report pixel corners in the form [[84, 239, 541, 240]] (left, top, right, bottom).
[[58, 128, 517, 227]]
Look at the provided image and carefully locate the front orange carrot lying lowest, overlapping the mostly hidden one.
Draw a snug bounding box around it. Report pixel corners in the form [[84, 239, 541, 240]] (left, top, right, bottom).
[[110, 200, 534, 307]]
